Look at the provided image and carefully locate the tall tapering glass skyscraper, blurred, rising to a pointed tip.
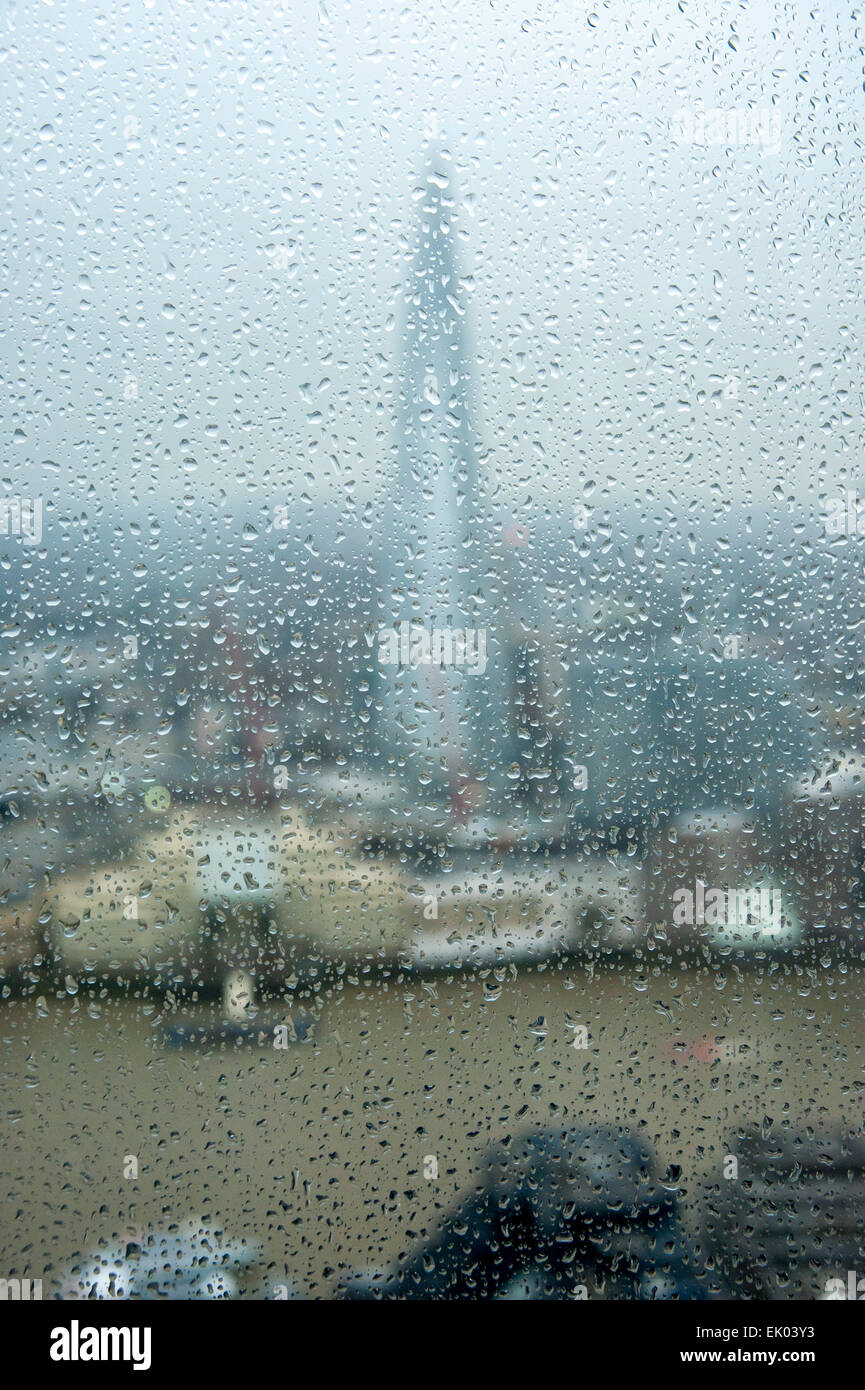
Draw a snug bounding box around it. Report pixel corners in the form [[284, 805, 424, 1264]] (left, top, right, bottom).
[[380, 154, 488, 813]]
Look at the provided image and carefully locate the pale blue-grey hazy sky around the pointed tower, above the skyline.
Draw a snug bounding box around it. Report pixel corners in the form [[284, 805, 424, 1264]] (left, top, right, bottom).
[[0, 0, 865, 536]]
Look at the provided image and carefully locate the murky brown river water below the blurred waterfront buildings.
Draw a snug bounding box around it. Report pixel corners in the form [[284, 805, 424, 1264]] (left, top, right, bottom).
[[0, 956, 865, 1297]]
